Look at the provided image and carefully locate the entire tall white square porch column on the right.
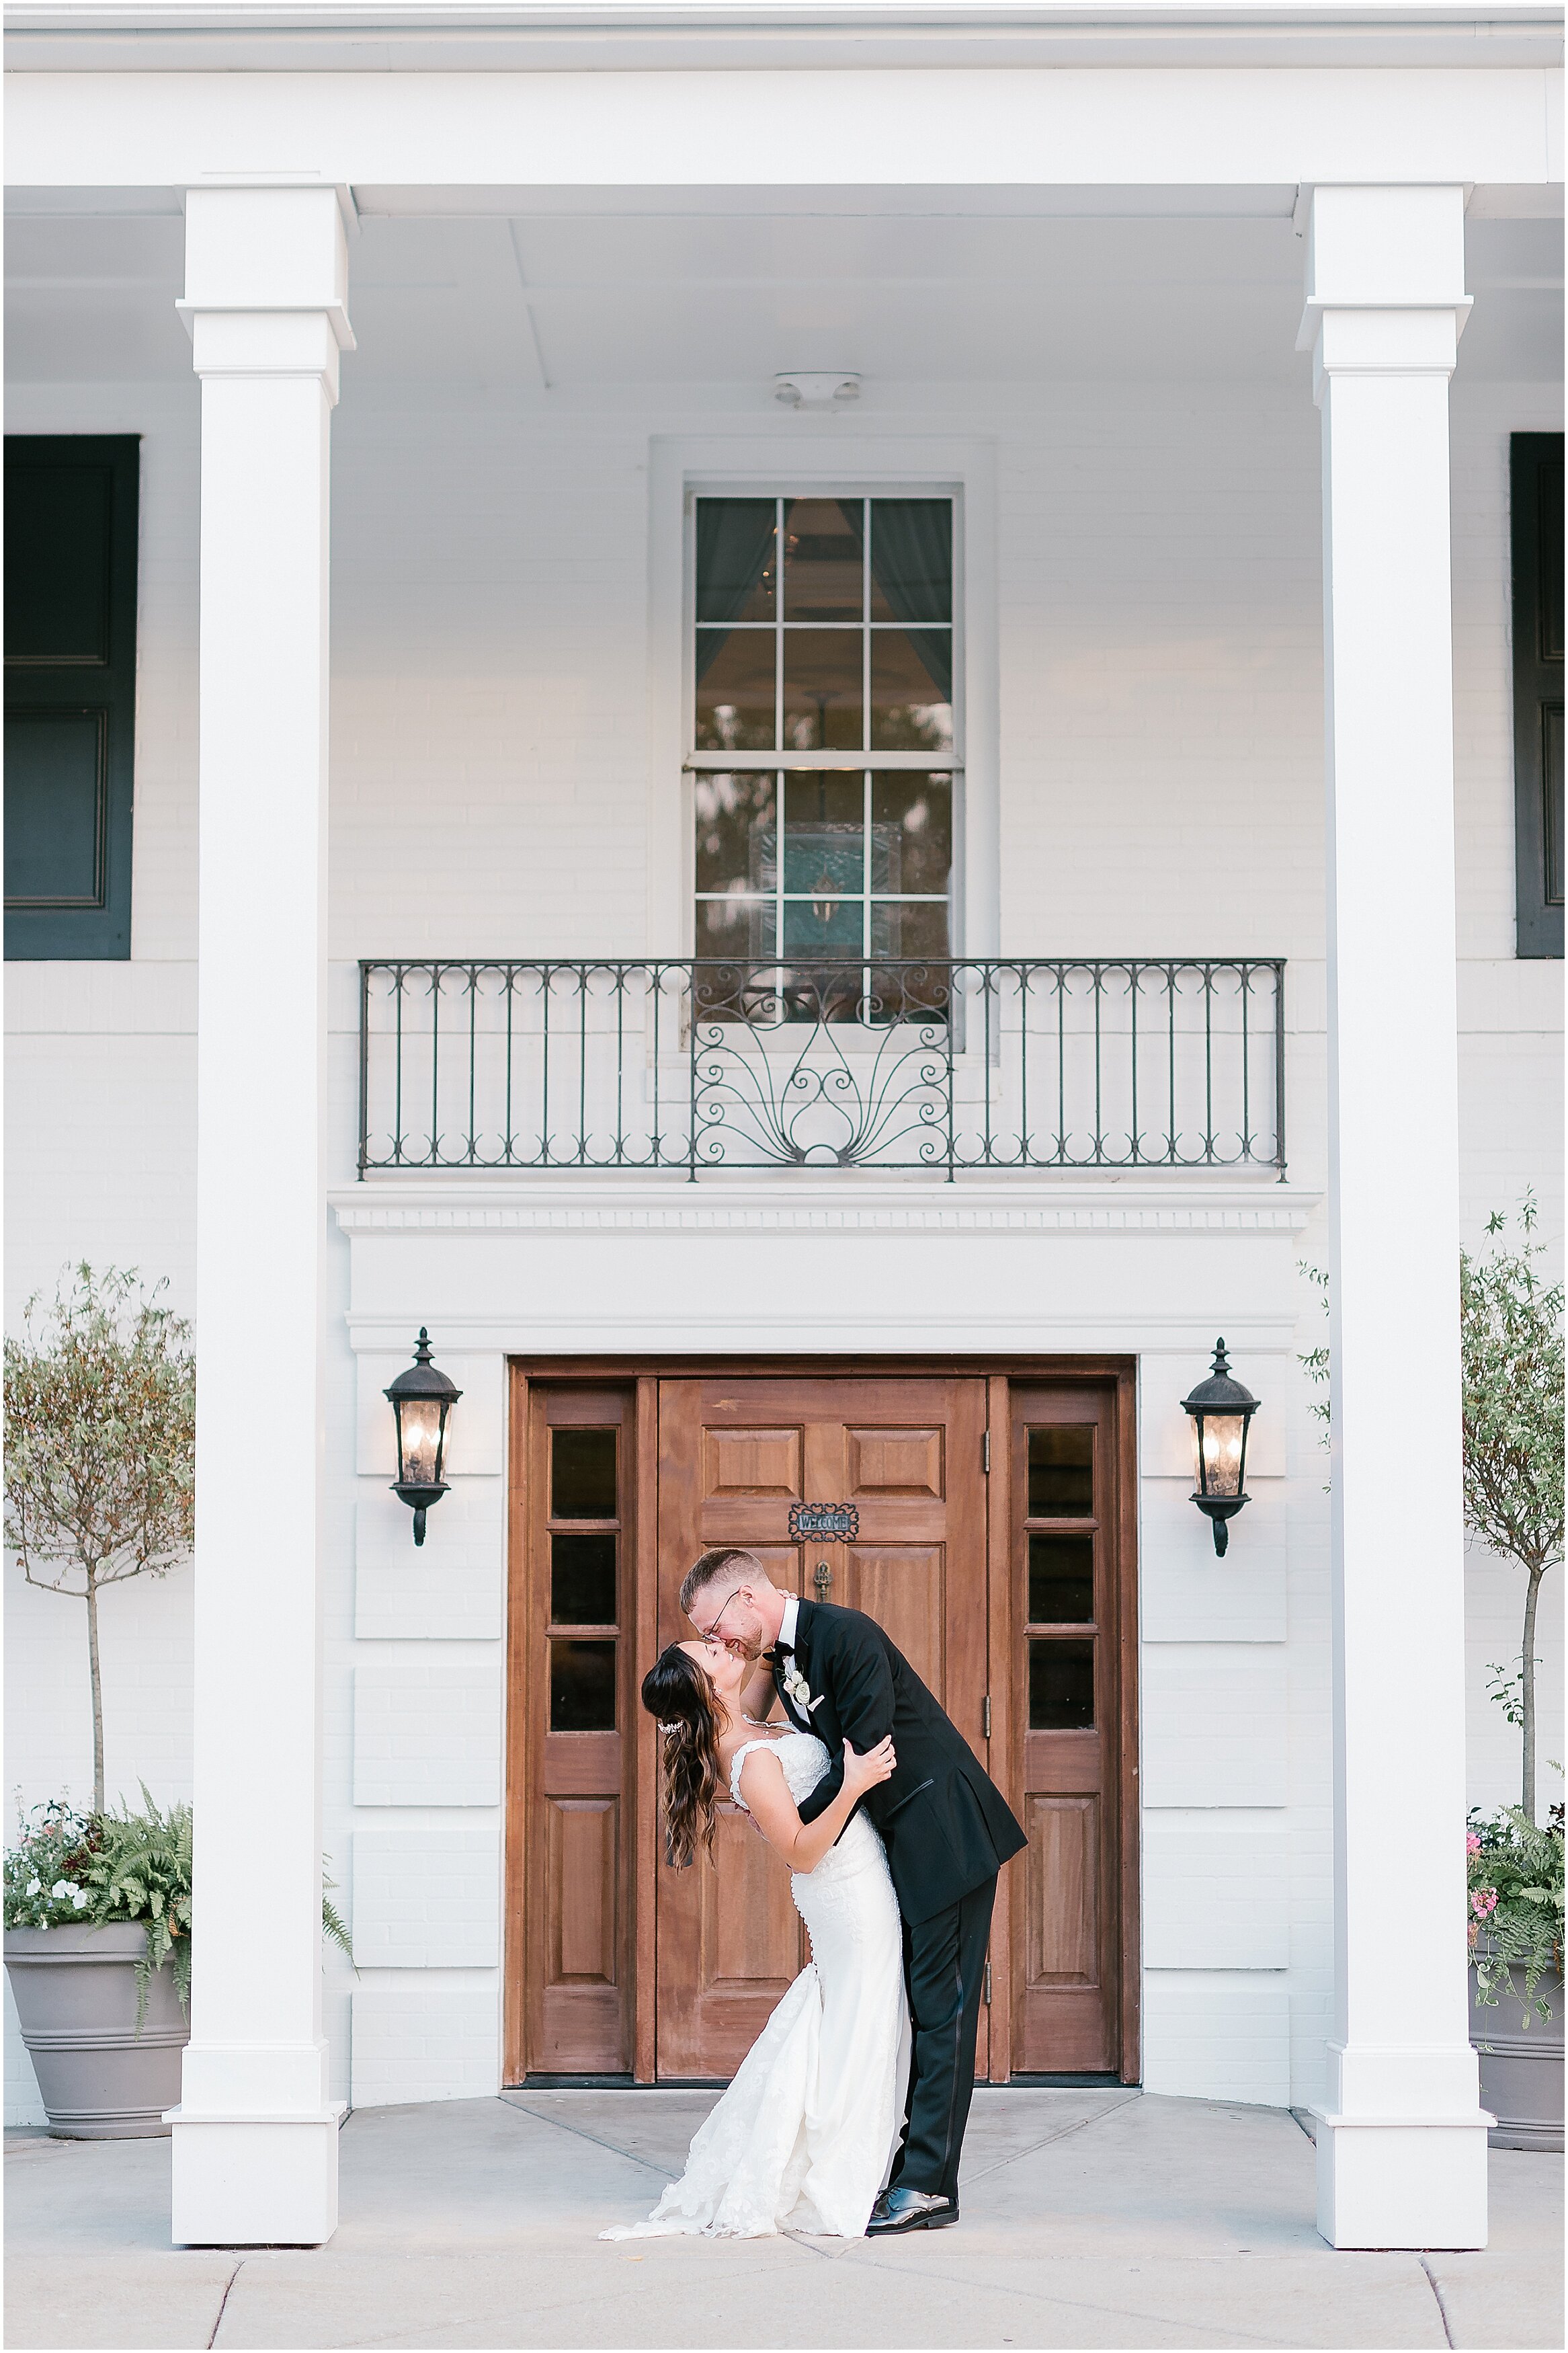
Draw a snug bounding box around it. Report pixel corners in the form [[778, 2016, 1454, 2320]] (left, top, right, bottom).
[[1303, 188, 1488, 2247]]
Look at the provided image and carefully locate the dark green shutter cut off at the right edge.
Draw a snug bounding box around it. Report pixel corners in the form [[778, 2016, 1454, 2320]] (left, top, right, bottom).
[[1510, 433, 1563, 955]]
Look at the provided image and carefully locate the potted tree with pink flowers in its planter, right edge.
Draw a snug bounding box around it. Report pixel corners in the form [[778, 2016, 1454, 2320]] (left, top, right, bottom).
[[1460, 1195, 1563, 2149]]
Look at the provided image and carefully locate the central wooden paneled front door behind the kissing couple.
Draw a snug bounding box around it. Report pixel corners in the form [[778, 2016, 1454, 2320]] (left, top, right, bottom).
[[658, 1377, 985, 2080]]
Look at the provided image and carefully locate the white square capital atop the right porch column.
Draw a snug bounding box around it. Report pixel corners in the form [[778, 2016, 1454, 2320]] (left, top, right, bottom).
[[1295, 186, 1469, 383]]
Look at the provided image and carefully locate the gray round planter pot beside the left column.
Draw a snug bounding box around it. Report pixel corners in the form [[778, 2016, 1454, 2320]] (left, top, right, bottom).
[[5, 1923, 190, 2141]]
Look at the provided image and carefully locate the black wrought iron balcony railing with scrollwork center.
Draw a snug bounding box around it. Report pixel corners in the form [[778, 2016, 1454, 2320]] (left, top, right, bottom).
[[360, 955, 1286, 1179]]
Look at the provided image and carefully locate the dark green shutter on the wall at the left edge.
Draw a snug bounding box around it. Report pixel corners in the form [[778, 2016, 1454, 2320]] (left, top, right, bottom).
[[5, 433, 141, 958]]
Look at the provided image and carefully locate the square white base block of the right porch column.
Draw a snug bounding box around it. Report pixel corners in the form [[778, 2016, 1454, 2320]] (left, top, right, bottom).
[[1309, 2108, 1495, 2249]]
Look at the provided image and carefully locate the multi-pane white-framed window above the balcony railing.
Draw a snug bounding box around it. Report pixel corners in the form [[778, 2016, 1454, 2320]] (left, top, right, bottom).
[[689, 497, 959, 965]]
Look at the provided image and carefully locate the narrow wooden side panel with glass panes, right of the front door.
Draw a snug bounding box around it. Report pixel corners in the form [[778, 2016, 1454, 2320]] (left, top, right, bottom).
[[1009, 1386, 1124, 2073]]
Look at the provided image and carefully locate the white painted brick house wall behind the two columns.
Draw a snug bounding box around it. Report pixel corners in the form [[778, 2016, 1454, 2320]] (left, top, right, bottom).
[[7, 341, 1563, 2127]]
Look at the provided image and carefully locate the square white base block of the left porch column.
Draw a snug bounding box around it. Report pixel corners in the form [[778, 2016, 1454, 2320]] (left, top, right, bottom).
[[167, 2099, 345, 2247]]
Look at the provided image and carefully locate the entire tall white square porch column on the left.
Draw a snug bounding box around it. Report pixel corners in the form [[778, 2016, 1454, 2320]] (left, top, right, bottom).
[[171, 186, 350, 2245]]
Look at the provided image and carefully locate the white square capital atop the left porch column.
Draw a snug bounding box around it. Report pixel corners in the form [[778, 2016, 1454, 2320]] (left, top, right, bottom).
[[174, 186, 355, 403]]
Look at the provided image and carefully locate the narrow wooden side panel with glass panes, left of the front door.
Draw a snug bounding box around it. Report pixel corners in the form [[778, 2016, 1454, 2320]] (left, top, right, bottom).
[[513, 1388, 637, 2075]]
